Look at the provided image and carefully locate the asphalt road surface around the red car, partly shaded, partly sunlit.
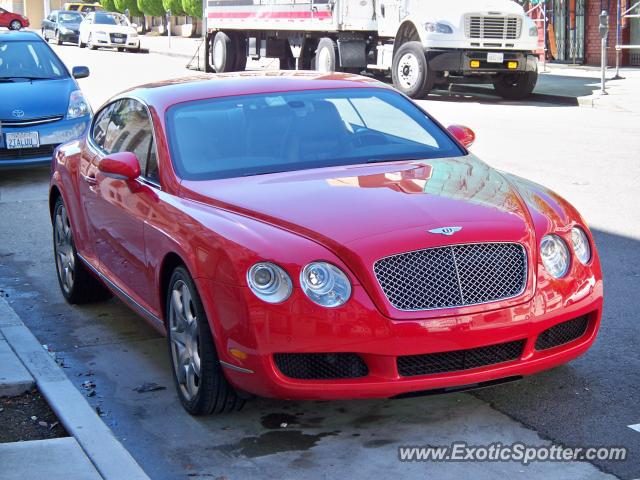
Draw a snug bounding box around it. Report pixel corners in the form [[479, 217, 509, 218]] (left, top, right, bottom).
[[0, 46, 640, 479]]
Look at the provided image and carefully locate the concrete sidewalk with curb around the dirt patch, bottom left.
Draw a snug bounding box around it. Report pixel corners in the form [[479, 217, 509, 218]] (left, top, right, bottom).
[[0, 298, 148, 480]]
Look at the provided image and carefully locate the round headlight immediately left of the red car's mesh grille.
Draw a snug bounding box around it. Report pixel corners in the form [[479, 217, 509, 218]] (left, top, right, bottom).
[[300, 262, 351, 308]]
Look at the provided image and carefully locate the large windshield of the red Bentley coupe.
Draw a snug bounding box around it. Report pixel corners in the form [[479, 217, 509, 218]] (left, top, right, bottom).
[[167, 88, 464, 180]]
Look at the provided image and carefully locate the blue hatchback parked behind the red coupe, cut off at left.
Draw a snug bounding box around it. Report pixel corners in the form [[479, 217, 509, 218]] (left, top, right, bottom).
[[0, 32, 91, 169]]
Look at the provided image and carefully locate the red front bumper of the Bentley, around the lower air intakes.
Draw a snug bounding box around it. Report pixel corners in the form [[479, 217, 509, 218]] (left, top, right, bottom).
[[199, 277, 602, 400]]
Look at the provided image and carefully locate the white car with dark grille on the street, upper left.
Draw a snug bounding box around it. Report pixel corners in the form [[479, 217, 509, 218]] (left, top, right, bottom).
[[78, 12, 140, 51]]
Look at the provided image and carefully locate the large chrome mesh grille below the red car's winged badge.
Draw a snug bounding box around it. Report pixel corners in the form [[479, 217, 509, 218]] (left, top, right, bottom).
[[373, 243, 527, 311]]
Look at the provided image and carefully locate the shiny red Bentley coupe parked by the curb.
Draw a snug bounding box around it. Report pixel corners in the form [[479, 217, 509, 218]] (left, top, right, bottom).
[[50, 72, 602, 414]]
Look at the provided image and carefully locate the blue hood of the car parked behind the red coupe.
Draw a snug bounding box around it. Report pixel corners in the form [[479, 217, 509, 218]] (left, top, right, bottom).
[[0, 78, 73, 121]]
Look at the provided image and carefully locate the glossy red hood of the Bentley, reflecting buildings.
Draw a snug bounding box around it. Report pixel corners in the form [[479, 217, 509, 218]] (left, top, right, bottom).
[[182, 155, 530, 254]]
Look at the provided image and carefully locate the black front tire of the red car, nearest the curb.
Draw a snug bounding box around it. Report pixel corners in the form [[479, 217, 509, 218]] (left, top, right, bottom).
[[166, 266, 244, 415]]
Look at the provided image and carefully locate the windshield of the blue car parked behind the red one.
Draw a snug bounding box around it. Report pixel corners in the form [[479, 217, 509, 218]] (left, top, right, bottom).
[[0, 40, 68, 81]]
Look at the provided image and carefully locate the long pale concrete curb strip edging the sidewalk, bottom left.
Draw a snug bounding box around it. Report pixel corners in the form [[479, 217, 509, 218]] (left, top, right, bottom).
[[0, 298, 149, 480]]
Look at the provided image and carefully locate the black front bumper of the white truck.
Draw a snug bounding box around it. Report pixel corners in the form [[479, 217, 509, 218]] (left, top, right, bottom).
[[425, 49, 538, 76]]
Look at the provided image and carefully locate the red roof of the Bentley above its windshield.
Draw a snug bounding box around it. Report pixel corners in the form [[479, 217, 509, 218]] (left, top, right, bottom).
[[115, 70, 391, 112]]
